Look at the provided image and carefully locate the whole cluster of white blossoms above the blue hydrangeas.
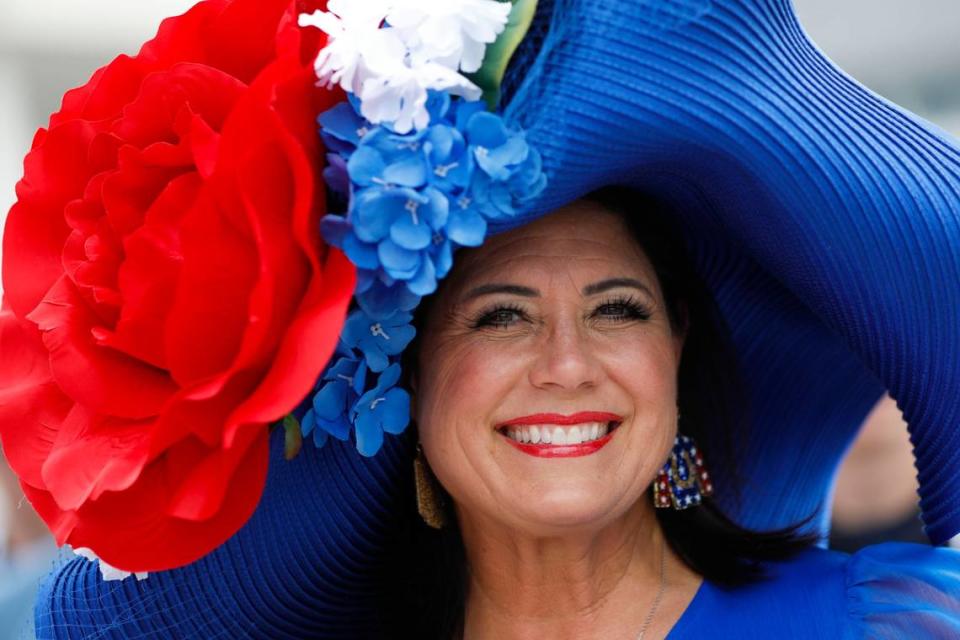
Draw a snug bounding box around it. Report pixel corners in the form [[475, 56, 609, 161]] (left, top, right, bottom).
[[300, 0, 512, 133]]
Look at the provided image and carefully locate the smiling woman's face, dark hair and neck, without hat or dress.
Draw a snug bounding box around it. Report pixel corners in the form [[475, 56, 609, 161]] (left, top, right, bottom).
[[386, 188, 817, 638]]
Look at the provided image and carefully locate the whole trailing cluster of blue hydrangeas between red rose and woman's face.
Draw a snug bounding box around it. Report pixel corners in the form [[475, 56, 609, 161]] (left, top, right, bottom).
[[310, 91, 546, 456]]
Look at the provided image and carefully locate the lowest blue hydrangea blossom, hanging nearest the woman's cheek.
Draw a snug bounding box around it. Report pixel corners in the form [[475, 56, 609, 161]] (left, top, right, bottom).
[[352, 364, 410, 457]]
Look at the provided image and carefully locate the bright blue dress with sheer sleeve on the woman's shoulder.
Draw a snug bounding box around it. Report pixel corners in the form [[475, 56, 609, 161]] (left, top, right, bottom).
[[667, 542, 960, 640]]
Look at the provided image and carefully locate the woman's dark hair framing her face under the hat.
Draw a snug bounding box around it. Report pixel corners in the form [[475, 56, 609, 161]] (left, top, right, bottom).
[[386, 187, 819, 640]]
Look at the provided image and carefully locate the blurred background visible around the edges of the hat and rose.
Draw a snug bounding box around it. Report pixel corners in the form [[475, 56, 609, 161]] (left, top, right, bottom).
[[0, 0, 960, 640]]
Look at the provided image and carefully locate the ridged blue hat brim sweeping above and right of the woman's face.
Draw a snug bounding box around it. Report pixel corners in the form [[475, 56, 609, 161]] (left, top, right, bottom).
[[491, 0, 960, 543]]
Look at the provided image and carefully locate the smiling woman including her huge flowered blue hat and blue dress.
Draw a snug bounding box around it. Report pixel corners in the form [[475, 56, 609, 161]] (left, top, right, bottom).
[[0, 0, 960, 638]]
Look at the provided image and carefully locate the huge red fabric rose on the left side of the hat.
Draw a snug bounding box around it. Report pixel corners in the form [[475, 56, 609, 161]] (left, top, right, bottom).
[[0, 0, 355, 571]]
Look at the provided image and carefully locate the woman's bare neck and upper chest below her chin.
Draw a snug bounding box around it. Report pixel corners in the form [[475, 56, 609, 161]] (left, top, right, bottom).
[[460, 500, 700, 640]]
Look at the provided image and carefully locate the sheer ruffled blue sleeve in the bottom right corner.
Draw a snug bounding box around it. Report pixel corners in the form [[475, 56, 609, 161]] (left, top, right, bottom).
[[846, 542, 960, 640]]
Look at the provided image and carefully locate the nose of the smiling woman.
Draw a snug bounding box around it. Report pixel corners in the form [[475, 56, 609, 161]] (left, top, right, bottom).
[[530, 321, 602, 391]]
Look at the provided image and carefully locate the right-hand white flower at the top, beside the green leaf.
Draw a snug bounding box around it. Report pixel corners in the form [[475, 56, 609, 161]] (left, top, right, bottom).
[[387, 0, 512, 73]]
